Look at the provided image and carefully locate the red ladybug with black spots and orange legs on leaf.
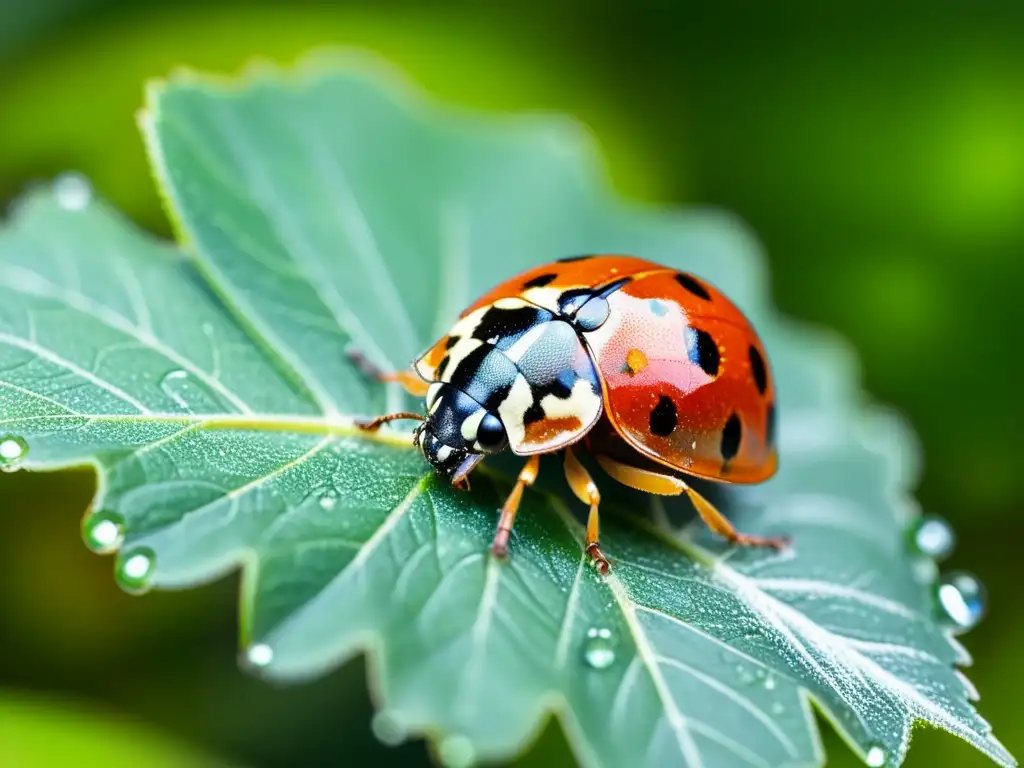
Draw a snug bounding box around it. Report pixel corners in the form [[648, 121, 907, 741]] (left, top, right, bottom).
[[352, 255, 785, 572]]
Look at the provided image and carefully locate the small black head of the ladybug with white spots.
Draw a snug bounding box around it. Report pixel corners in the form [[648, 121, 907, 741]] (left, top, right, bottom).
[[415, 383, 508, 482]]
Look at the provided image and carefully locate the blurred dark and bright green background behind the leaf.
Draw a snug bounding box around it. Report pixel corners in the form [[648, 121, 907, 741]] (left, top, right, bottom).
[[0, 0, 1024, 768]]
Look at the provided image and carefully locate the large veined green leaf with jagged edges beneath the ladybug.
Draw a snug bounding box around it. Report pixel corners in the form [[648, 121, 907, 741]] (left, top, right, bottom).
[[0, 51, 1015, 768]]
